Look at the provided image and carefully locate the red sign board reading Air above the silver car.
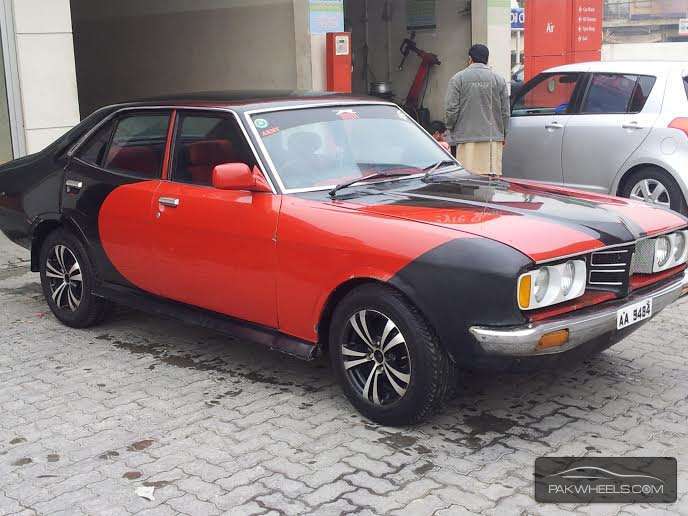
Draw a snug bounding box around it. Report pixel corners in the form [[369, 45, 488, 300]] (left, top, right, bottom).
[[525, 0, 604, 80]]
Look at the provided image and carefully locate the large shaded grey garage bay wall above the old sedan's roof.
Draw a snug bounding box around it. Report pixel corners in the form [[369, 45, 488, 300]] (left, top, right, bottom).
[[72, 0, 297, 115]]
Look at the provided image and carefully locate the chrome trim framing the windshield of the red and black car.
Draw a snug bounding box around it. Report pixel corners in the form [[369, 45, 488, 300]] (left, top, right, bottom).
[[244, 100, 461, 194]]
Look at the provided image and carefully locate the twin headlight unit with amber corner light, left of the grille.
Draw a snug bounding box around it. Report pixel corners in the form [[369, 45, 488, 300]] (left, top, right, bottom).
[[517, 260, 587, 310]]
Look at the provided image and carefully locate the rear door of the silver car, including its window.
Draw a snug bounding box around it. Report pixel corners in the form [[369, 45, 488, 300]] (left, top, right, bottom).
[[563, 73, 664, 193]]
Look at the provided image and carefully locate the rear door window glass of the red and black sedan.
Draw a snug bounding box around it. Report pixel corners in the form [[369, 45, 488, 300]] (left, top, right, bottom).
[[101, 113, 170, 179]]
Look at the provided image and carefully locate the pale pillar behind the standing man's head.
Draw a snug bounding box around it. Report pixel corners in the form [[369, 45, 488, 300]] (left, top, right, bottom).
[[471, 0, 511, 81]]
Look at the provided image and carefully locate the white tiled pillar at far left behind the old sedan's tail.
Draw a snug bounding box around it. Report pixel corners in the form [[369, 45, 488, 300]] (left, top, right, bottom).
[[13, 0, 79, 153]]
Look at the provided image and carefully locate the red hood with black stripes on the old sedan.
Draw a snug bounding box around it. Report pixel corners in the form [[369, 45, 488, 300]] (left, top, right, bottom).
[[324, 172, 687, 261]]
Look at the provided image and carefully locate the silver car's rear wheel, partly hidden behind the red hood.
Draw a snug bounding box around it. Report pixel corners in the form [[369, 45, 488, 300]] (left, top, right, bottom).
[[619, 166, 688, 215]]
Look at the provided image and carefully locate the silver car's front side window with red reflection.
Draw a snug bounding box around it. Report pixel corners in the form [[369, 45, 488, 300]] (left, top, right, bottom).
[[511, 73, 581, 116]]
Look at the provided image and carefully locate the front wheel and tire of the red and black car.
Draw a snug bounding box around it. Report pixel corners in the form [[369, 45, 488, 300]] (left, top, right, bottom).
[[329, 284, 455, 426]]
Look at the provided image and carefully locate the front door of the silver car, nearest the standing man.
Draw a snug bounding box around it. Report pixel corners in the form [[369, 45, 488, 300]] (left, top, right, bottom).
[[503, 72, 583, 183]]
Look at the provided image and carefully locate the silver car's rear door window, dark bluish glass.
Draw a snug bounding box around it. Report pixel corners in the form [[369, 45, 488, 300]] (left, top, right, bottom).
[[581, 73, 655, 114]]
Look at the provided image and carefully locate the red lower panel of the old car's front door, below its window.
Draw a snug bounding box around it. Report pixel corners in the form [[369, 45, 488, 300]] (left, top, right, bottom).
[[149, 181, 281, 328]]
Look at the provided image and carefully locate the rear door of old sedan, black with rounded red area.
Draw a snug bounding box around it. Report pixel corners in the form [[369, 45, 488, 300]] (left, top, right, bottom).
[[62, 110, 171, 292]]
